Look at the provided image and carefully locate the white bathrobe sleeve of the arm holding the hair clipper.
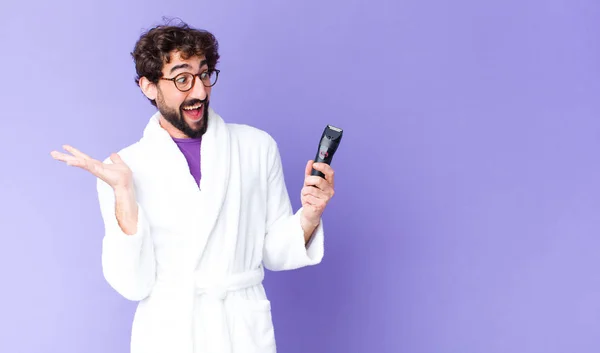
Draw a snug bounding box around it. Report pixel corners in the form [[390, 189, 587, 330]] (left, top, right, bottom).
[[263, 138, 324, 271]]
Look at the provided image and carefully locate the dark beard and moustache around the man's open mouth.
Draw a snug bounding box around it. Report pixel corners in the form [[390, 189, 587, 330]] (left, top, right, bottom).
[[156, 91, 209, 138]]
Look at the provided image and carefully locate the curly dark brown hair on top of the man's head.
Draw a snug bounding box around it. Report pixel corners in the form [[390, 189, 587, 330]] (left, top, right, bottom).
[[131, 21, 220, 106]]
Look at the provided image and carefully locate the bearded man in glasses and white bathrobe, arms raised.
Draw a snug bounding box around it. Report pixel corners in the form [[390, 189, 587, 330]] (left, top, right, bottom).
[[51, 20, 334, 353]]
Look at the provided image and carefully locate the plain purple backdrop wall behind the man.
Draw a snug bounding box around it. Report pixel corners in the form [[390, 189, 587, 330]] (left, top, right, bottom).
[[0, 0, 600, 353]]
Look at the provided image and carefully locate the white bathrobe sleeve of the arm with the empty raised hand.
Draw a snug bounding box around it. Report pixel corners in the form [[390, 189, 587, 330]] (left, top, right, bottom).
[[97, 170, 156, 301]]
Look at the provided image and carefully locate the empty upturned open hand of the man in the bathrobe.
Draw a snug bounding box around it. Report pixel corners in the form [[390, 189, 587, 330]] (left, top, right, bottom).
[[50, 145, 132, 189]]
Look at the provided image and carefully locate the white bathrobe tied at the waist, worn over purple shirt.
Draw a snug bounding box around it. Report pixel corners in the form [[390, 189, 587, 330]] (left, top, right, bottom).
[[97, 109, 323, 353]]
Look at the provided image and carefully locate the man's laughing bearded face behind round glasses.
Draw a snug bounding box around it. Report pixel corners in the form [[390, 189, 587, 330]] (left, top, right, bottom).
[[156, 52, 211, 138]]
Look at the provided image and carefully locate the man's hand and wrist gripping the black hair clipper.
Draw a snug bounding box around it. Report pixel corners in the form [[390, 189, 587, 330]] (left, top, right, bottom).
[[300, 160, 334, 236]]
